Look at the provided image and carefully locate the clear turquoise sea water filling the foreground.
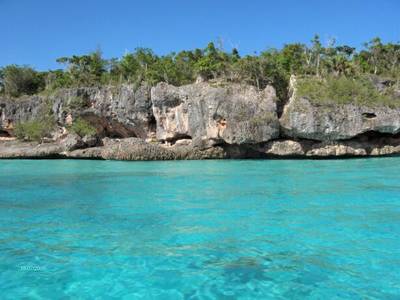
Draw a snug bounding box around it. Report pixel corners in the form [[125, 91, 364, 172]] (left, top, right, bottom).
[[0, 158, 400, 300]]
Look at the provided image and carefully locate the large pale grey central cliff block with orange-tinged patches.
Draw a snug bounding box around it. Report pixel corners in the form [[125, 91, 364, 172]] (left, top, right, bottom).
[[151, 83, 279, 148]]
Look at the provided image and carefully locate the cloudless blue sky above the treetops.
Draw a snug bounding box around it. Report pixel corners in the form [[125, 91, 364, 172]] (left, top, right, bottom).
[[0, 0, 400, 70]]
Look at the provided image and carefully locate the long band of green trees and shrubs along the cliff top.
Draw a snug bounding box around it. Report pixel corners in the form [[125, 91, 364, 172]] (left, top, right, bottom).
[[0, 35, 400, 101]]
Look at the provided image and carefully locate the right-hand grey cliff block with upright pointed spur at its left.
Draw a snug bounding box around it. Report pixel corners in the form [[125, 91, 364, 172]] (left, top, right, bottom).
[[280, 77, 400, 141]]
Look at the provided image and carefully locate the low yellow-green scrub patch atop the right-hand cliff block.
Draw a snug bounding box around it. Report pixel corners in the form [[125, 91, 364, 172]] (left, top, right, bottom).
[[297, 76, 400, 107]]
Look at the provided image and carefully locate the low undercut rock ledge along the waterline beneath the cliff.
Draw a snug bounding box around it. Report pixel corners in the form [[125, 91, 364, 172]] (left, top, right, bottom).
[[0, 137, 400, 160]]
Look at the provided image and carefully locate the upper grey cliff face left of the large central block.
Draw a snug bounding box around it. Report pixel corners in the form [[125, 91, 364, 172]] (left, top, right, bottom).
[[0, 85, 155, 138]]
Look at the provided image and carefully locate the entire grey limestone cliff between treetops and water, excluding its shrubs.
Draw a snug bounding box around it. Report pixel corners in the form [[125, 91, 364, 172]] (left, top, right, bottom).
[[0, 78, 400, 160]]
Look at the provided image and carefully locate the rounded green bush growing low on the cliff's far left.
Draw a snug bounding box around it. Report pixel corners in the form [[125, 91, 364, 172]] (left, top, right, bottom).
[[14, 117, 55, 141]]
